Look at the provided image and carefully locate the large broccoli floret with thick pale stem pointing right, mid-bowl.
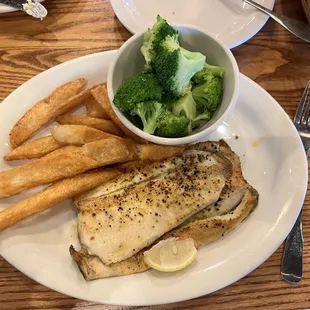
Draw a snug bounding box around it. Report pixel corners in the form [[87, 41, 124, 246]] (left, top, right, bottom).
[[154, 35, 206, 98]]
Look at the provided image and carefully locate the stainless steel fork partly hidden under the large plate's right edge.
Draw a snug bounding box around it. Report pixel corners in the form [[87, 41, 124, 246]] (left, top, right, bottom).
[[281, 81, 310, 284]]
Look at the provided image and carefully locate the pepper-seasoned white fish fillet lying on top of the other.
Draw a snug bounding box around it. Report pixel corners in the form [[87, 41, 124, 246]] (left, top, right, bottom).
[[77, 150, 230, 265]]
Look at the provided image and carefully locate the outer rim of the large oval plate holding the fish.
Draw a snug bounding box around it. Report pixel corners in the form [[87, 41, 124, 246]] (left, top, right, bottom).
[[0, 50, 308, 306]]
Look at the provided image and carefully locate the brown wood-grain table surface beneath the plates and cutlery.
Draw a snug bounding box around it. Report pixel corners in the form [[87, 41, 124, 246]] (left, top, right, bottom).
[[0, 0, 310, 310]]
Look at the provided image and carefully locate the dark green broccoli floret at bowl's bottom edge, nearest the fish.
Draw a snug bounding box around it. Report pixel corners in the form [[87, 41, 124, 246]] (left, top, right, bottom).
[[155, 110, 190, 138]]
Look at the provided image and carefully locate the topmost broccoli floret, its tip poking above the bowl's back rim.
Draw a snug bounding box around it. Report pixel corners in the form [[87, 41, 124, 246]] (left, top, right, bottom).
[[141, 15, 179, 69]]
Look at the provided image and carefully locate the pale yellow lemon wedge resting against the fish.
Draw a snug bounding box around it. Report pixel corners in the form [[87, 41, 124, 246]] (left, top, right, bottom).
[[144, 238, 197, 272]]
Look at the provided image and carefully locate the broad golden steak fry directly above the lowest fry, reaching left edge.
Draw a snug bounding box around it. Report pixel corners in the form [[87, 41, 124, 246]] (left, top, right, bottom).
[[0, 137, 184, 198]]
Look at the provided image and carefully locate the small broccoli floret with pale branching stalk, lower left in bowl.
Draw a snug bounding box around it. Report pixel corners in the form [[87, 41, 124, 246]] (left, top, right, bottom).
[[131, 101, 163, 134]]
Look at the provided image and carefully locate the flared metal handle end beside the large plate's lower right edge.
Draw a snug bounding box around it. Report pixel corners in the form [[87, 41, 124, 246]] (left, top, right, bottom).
[[281, 212, 304, 284]]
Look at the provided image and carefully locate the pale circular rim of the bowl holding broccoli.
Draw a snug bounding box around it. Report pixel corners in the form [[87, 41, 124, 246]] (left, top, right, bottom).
[[107, 24, 240, 145]]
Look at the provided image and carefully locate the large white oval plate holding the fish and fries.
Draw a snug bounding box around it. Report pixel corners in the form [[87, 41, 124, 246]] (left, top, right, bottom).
[[0, 51, 307, 305]]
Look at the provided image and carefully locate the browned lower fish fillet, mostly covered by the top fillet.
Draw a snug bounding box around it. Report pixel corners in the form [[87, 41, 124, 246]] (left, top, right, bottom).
[[70, 141, 258, 281]]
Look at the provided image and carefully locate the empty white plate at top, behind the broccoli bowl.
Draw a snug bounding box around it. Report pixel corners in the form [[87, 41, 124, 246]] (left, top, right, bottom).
[[111, 0, 275, 48]]
